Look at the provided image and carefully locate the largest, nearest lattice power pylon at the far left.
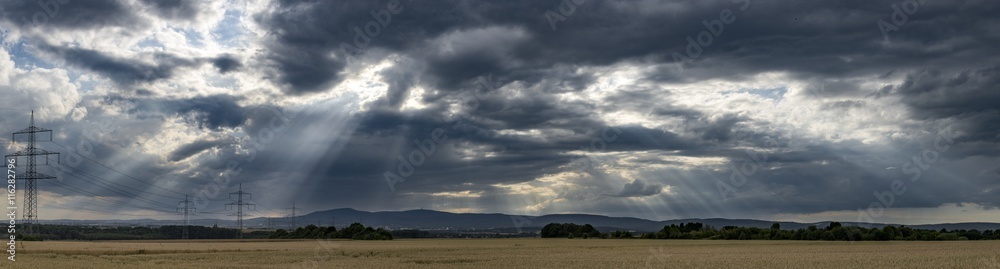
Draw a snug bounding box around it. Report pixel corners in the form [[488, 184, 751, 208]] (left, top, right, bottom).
[[6, 110, 59, 233]]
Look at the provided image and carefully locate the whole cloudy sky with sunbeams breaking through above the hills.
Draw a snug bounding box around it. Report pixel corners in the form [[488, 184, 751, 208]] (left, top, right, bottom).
[[0, 0, 1000, 224]]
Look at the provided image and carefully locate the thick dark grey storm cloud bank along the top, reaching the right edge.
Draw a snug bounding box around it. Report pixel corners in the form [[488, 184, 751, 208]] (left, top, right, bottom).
[[258, 1, 1000, 98]]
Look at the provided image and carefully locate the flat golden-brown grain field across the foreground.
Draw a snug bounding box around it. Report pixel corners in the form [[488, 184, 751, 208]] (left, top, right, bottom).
[[0, 239, 1000, 269]]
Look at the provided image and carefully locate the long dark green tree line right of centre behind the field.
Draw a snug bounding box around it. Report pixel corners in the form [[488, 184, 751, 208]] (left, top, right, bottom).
[[541, 222, 1000, 241]]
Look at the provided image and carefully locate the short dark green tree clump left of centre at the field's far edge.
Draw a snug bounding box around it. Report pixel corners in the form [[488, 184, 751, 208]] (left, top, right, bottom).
[[269, 223, 392, 240]]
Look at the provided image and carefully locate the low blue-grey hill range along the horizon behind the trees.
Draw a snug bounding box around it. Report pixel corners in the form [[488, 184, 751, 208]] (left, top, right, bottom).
[[43, 208, 1000, 232]]
